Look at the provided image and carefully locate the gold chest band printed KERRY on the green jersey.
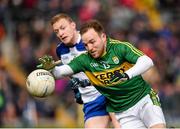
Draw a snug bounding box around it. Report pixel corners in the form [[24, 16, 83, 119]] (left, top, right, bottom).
[[85, 62, 133, 86]]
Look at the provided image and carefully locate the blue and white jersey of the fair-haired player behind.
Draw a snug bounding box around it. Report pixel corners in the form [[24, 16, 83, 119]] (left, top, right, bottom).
[[56, 34, 101, 103]]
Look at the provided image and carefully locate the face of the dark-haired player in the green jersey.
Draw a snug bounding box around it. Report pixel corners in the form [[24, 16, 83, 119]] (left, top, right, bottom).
[[82, 29, 106, 58]]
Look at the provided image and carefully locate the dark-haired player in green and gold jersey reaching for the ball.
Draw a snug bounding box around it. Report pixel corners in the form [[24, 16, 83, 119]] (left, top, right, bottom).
[[41, 20, 166, 128]]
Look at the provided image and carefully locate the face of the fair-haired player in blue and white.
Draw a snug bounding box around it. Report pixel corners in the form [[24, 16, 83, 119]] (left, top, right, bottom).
[[52, 18, 76, 45]]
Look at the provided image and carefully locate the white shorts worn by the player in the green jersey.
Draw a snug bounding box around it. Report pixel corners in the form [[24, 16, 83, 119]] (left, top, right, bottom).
[[115, 94, 166, 129]]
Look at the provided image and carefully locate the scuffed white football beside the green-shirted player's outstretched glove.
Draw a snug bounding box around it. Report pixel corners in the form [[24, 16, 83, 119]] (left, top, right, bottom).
[[26, 69, 55, 97]]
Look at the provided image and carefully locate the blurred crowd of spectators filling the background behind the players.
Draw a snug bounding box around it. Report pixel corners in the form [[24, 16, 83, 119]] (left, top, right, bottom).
[[0, 0, 180, 127]]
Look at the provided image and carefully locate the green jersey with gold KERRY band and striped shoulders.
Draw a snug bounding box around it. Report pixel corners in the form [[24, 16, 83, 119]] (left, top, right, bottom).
[[69, 38, 151, 112]]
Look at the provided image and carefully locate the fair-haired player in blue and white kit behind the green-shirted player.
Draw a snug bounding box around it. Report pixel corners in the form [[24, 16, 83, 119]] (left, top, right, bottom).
[[48, 13, 119, 128]]
